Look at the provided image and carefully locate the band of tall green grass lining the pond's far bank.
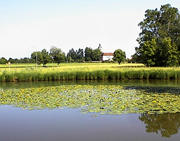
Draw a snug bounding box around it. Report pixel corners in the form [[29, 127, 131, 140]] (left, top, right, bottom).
[[0, 67, 180, 82]]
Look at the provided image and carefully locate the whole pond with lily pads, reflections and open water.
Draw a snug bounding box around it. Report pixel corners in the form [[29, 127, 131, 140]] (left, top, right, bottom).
[[0, 81, 180, 141]]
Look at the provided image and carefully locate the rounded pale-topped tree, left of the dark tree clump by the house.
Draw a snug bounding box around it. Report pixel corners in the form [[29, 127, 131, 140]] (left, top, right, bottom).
[[50, 47, 66, 65]]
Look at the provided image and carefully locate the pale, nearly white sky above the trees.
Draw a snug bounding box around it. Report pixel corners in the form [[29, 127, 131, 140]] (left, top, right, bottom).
[[0, 0, 180, 59]]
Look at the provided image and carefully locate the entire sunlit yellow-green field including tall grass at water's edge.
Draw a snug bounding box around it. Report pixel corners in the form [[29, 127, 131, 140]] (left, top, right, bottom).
[[0, 63, 180, 82]]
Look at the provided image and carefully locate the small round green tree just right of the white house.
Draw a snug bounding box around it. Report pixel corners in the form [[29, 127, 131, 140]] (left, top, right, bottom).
[[113, 49, 126, 64]]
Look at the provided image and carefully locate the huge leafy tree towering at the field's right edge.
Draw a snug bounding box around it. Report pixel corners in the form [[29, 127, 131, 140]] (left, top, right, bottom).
[[135, 4, 180, 66]]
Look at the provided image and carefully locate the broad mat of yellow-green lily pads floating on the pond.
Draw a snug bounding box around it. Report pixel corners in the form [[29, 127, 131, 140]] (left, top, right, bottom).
[[0, 85, 180, 114]]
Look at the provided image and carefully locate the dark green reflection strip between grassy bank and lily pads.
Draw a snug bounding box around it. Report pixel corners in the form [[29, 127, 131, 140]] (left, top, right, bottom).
[[0, 80, 180, 89]]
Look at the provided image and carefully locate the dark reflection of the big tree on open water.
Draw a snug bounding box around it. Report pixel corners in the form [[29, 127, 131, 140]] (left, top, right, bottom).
[[139, 113, 180, 137]]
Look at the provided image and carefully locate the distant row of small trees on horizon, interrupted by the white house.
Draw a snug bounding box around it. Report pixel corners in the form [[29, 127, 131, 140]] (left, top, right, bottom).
[[0, 44, 126, 66]]
